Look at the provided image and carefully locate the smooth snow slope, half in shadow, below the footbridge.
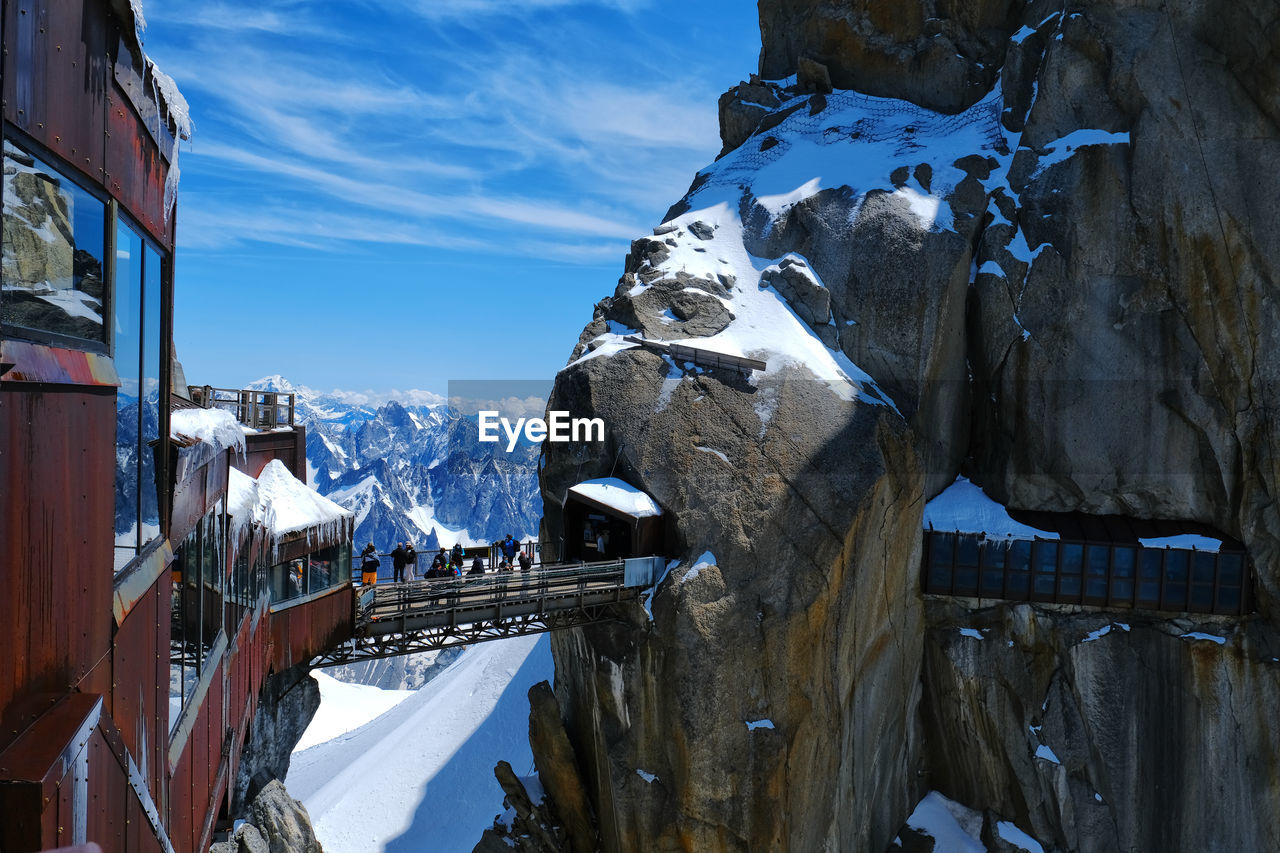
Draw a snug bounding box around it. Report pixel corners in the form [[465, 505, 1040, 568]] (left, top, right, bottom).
[[285, 635, 553, 853]]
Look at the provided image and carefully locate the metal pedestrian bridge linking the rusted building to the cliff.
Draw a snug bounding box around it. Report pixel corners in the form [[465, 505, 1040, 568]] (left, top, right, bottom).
[[311, 557, 666, 667]]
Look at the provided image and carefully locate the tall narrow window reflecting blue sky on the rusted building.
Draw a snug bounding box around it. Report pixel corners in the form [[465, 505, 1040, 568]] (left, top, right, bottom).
[[110, 218, 164, 571]]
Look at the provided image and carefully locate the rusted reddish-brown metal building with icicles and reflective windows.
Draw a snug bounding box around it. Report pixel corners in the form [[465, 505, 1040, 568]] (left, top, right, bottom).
[[0, 0, 352, 853]]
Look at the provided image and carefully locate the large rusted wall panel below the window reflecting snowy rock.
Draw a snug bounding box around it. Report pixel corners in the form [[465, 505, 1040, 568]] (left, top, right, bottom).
[[0, 384, 115, 708]]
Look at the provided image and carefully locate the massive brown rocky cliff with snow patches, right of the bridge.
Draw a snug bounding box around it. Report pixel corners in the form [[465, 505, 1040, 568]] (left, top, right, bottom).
[[541, 0, 1280, 850]]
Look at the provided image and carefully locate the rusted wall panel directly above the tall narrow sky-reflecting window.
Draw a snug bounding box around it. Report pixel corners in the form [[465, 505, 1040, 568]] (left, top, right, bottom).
[[106, 77, 170, 246]]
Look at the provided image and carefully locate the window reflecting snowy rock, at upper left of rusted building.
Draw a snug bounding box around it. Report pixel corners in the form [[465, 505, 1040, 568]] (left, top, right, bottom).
[[0, 140, 108, 351]]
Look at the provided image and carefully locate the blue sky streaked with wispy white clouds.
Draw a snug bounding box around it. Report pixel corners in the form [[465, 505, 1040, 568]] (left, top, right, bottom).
[[145, 0, 759, 393]]
